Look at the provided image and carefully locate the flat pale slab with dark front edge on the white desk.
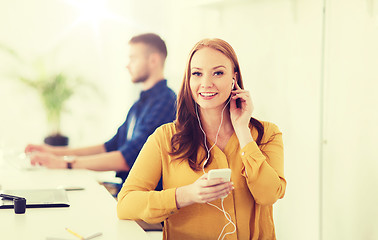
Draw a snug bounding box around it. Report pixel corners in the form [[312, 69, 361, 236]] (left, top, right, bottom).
[[0, 188, 70, 209]]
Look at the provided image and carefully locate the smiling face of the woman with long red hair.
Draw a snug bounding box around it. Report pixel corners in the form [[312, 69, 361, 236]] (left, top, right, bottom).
[[189, 47, 235, 109]]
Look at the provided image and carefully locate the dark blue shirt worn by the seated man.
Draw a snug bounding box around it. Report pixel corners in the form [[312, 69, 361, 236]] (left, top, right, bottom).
[[105, 79, 176, 188]]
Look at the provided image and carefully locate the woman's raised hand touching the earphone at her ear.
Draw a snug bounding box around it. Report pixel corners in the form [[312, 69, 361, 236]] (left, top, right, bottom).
[[230, 82, 253, 131]]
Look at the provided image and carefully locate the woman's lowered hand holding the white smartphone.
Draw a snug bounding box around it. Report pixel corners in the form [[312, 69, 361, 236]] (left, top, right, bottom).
[[176, 173, 234, 208]]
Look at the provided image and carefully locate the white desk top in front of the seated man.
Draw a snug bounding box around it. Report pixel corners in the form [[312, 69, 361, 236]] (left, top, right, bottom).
[[0, 159, 149, 240]]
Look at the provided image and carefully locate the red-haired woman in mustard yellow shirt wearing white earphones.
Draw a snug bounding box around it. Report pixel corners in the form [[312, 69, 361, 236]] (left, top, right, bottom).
[[117, 39, 286, 240]]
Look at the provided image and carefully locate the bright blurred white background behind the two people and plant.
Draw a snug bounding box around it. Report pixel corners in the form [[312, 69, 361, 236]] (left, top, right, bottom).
[[0, 0, 378, 240]]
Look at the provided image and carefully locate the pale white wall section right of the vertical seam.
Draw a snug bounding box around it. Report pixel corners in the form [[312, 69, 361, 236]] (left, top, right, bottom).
[[322, 0, 378, 240]]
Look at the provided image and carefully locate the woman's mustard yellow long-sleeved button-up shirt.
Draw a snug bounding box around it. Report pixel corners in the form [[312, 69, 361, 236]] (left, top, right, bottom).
[[117, 122, 286, 240]]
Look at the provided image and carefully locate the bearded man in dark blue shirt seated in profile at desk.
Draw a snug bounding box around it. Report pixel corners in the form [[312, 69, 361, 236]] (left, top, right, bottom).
[[25, 33, 176, 190]]
